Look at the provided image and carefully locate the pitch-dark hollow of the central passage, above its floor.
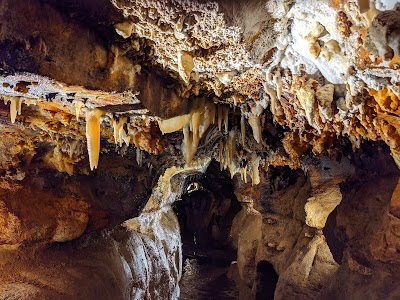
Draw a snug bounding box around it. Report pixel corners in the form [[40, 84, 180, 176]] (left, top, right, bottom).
[[174, 162, 241, 264]]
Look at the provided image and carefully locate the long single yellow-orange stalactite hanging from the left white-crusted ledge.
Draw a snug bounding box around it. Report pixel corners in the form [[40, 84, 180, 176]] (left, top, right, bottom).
[[86, 108, 103, 170]]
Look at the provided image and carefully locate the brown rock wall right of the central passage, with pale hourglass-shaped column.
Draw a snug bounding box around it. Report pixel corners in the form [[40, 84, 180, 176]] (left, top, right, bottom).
[[230, 147, 400, 299]]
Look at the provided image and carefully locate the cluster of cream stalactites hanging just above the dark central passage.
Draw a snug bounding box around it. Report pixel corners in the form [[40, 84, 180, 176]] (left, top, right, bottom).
[[159, 100, 262, 184]]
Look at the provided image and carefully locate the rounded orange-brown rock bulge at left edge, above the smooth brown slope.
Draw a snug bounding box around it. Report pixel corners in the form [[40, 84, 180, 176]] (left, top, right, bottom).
[[0, 180, 89, 247]]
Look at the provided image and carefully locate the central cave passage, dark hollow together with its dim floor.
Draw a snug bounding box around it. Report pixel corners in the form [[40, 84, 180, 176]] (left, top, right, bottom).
[[174, 162, 241, 299]]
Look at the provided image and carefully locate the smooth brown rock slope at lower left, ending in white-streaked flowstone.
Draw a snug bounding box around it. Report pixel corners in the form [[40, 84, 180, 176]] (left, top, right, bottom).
[[0, 225, 180, 299]]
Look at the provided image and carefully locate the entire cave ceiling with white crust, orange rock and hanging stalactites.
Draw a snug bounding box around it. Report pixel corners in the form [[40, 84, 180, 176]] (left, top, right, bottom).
[[0, 0, 400, 178]]
